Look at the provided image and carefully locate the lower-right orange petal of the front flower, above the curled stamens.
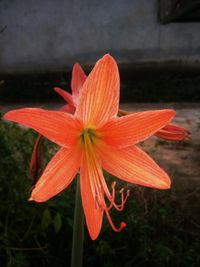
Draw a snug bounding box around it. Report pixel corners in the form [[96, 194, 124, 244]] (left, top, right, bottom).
[[101, 146, 171, 189]]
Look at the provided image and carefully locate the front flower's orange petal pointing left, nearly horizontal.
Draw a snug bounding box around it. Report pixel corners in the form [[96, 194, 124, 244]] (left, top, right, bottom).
[[4, 108, 79, 146]]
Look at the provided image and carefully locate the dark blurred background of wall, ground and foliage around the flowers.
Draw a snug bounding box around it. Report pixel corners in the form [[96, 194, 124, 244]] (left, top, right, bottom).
[[0, 0, 200, 267]]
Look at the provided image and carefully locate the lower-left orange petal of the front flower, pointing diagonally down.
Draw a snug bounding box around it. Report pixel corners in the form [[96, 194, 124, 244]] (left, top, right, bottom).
[[30, 147, 81, 202]]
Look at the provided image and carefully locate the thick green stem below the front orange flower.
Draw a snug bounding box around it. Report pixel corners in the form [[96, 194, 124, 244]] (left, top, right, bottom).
[[71, 177, 84, 267]]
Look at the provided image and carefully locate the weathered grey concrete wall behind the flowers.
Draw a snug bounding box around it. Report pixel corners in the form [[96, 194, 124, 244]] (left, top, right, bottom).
[[0, 0, 200, 74]]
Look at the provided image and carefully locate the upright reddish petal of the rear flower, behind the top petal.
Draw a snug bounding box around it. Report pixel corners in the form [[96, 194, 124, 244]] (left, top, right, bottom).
[[71, 63, 87, 104]]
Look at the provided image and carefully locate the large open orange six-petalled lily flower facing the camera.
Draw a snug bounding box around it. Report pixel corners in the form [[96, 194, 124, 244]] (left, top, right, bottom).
[[4, 55, 175, 240]]
